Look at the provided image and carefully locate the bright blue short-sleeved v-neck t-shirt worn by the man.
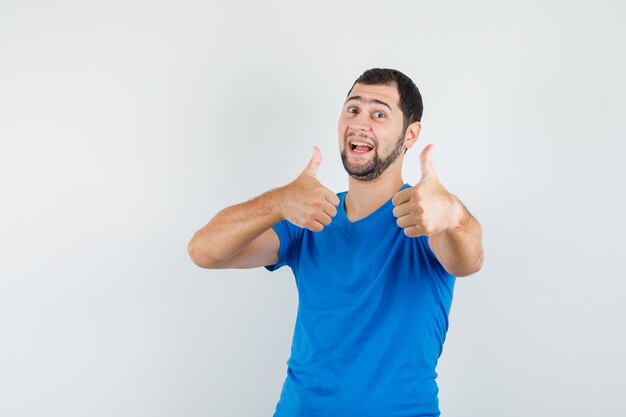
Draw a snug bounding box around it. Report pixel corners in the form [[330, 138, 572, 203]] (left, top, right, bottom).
[[266, 184, 456, 417]]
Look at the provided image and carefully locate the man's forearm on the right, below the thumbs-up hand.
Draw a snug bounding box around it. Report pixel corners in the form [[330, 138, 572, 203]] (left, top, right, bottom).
[[429, 197, 484, 277]]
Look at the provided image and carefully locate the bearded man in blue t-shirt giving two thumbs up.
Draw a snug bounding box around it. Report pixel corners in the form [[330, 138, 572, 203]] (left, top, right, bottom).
[[189, 68, 483, 417]]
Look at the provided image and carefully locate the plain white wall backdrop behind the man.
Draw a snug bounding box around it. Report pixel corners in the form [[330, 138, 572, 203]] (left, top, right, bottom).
[[0, 0, 626, 417]]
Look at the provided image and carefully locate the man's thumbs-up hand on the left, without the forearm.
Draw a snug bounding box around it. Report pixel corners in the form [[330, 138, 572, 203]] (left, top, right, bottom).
[[280, 146, 339, 232]]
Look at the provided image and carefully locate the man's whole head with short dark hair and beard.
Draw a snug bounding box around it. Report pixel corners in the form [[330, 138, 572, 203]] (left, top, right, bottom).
[[338, 68, 423, 181]]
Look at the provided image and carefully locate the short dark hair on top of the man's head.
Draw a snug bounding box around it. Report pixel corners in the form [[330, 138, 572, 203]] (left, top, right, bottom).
[[348, 68, 424, 132]]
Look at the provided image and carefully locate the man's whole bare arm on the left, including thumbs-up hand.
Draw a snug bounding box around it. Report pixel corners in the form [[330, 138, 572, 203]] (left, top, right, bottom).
[[187, 148, 339, 269]]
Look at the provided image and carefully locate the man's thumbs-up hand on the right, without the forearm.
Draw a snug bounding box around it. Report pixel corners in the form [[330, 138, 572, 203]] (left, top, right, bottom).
[[391, 144, 461, 237]]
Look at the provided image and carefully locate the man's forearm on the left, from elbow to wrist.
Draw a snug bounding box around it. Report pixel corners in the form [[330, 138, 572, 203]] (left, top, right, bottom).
[[188, 188, 284, 263]]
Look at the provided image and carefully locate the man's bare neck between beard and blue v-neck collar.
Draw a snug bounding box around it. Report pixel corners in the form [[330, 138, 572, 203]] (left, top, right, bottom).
[[345, 164, 404, 222]]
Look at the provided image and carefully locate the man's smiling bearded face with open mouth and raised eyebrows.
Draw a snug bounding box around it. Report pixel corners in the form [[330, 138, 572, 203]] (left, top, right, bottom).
[[338, 83, 412, 181]]
